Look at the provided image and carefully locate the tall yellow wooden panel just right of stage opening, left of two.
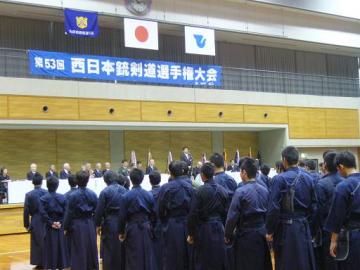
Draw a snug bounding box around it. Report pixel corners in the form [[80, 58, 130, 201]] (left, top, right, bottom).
[[288, 107, 326, 139]]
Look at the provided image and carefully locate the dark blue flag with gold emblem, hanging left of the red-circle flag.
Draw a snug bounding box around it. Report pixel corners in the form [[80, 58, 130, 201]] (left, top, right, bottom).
[[64, 9, 99, 37]]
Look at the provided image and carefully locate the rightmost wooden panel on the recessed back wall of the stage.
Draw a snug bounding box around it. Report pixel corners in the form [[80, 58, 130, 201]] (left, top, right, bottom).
[[224, 131, 260, 159]]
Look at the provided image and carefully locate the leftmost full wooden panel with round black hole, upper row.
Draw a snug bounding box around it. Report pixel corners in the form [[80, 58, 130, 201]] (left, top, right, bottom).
[[8, 96, 79, 120]]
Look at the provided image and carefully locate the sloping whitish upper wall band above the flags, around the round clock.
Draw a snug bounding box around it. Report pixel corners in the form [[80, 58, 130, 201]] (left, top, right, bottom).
[[7, 0, 360, 48]]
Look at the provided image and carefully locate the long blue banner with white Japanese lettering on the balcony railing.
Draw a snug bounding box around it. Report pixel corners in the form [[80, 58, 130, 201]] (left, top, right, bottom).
[[29, 50, 222, 86]]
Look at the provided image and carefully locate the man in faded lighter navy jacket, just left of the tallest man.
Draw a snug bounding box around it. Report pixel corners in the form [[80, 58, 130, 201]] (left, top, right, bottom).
[[225, 158, 272, 270]]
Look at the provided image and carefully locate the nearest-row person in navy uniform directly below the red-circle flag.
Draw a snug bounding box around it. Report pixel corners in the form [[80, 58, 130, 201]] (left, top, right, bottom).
[[119, 168, 156, 270]]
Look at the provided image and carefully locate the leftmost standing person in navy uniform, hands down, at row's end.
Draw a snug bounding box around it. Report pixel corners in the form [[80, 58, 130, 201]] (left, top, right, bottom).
[[24, 172, 47, 269]]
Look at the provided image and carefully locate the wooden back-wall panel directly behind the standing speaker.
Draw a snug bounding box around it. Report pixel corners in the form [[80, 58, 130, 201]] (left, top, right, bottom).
[[170, 131, 212, 165]]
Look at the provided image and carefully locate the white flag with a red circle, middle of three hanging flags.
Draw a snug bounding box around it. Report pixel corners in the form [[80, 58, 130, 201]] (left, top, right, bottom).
[[124, 18, 159, 50]]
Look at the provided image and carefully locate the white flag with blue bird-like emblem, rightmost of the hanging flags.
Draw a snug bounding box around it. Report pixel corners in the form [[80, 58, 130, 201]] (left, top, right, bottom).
[[185, 26, 215, 56]]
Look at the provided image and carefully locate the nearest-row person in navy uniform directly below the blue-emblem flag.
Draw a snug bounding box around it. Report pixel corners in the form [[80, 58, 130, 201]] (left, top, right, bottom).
[[187, 162, 228, 270]]
